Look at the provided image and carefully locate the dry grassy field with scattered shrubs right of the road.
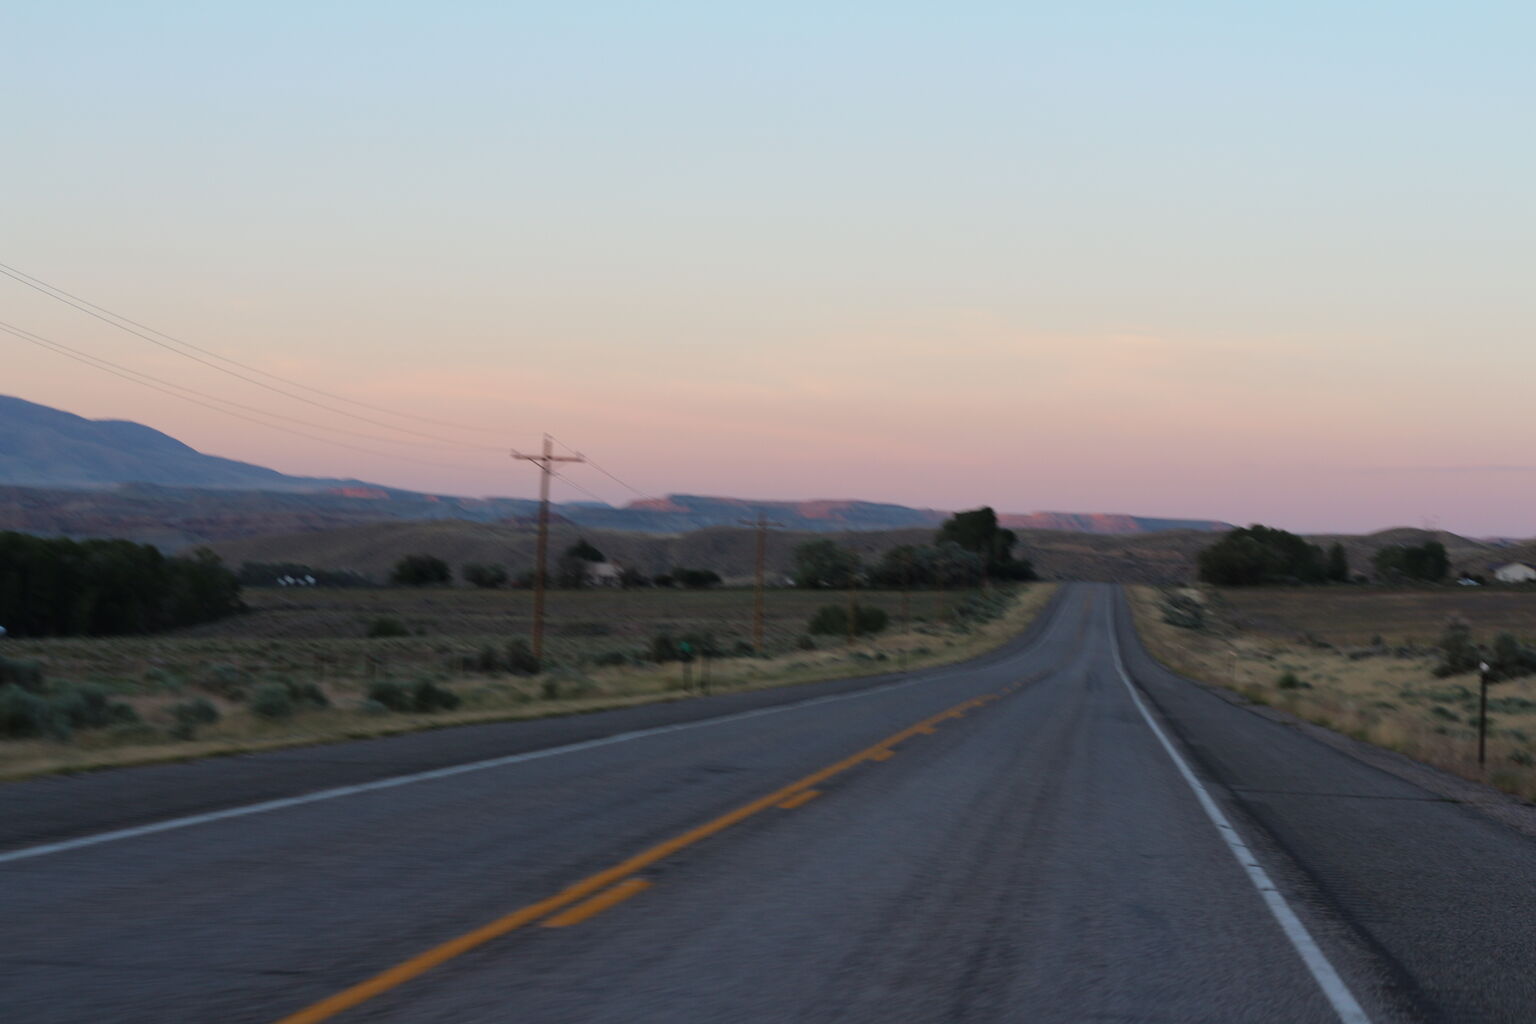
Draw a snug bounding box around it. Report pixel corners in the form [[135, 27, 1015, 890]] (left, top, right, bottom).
[[1132, 586, 1536, 798]]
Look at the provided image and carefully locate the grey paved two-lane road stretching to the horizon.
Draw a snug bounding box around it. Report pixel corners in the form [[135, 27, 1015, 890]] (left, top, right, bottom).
[[0, 585, 1536, 1024]]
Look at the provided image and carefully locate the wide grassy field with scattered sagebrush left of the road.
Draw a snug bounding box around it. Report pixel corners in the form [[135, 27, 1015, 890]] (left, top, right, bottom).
[[0, 583, 1054, 778]]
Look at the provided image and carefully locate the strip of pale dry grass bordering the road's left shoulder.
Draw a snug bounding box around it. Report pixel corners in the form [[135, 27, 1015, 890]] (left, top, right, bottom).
[[0, 583, 1055, 778]]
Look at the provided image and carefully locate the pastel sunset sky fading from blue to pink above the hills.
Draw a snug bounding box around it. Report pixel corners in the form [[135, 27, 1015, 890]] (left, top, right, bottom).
[[0, 0, 1536, 536]]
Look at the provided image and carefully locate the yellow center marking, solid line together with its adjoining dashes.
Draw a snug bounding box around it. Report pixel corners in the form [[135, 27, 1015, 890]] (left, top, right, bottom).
[[278, 680, 1034, 1024]]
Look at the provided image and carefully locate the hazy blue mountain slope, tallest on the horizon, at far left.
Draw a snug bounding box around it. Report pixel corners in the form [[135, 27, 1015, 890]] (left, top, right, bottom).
[[0, 395, 365, 491]]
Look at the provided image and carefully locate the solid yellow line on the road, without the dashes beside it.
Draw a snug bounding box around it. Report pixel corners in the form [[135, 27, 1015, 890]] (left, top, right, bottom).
[[278, 699, 985, 1024]]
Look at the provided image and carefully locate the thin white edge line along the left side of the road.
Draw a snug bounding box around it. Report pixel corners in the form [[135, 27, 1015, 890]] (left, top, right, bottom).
[[0, 657, 954, 864]]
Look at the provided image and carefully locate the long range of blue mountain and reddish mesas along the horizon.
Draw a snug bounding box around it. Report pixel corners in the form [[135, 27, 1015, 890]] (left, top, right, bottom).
[[0, 396, 1226, 550]]
